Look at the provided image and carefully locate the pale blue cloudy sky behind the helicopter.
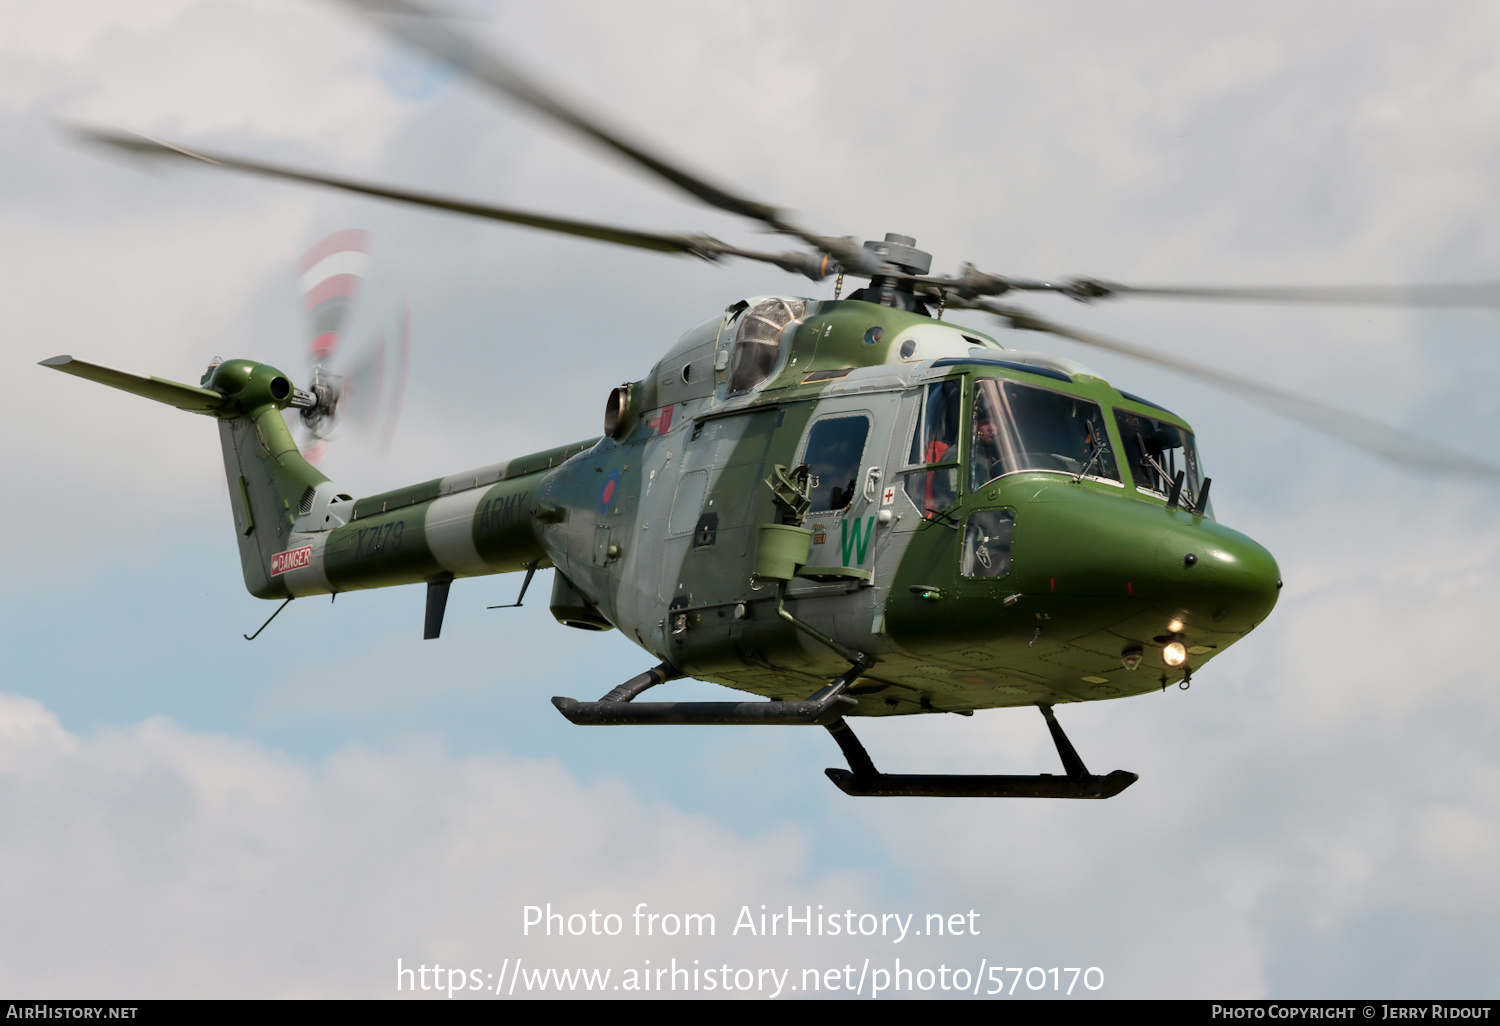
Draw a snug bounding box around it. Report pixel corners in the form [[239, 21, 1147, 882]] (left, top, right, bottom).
[[0, 0, 1500, 999]]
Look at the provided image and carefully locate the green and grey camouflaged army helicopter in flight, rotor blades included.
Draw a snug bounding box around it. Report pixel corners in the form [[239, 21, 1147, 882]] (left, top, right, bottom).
[[42, 0, 1500, 798]]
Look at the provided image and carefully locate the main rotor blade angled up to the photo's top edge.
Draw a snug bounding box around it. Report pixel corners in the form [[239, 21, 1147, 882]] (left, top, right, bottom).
[[341, 0, 788, 230]]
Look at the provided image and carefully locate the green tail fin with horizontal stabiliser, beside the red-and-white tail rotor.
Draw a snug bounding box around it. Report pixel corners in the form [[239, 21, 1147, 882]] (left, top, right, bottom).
[[42, 356, 338, 599]]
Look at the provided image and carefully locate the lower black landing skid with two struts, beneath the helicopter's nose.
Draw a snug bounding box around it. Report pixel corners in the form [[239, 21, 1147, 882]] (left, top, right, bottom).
[[824, 705, 1140, 798]]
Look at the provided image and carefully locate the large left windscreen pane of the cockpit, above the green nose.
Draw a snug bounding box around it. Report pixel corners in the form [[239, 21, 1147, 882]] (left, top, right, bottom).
[[969, 378, 1121, 488]]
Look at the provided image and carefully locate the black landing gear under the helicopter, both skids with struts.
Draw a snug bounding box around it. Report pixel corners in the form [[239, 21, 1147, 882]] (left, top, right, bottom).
[[552, 662, 1139, 798]]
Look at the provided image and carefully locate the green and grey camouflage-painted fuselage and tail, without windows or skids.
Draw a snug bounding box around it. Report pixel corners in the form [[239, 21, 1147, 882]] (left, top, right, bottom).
[[48, 297, 1280, 716]]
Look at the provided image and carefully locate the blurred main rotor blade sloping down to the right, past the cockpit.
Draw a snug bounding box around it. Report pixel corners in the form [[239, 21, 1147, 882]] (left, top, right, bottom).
[[972, 302, 1500, 483]]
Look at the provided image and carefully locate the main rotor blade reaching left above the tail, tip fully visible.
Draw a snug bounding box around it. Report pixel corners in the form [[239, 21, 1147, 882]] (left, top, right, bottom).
[[72, 128, 708, 257]]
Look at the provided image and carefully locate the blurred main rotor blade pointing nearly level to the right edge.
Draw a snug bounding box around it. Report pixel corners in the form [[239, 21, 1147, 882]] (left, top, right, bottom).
[[1080, 278, 1500, 311]]
